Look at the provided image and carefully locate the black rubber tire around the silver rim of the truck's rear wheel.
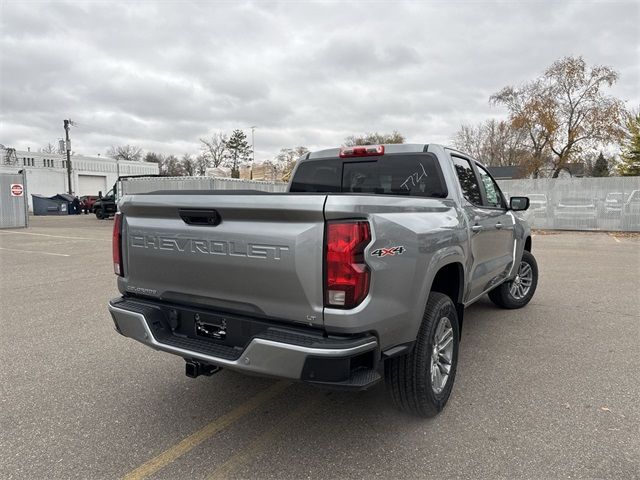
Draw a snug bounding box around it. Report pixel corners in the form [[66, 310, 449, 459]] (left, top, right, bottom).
[[384, 292, 460, 417]]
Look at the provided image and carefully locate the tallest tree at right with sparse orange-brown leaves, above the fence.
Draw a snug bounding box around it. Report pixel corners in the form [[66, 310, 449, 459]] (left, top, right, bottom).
[[491, 57, 625, 177]]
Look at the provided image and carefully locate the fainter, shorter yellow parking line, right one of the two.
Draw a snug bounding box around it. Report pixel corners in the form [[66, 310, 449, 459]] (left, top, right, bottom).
[[207, 393, 324, 480]]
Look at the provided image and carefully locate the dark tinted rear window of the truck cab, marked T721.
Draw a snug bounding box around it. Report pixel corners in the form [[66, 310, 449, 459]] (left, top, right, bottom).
[[291, 153, 447, 198]]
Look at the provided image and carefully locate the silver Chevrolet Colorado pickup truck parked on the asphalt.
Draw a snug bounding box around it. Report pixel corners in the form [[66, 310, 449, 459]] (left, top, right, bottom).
[[109, 144, 538, 416]]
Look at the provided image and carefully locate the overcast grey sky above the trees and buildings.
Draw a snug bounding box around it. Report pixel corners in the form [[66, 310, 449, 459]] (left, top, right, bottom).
[[0, 0, 640, 160]]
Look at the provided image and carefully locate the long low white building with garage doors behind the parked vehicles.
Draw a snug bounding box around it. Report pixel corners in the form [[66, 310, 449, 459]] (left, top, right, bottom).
[[0, 149, 159, 209]]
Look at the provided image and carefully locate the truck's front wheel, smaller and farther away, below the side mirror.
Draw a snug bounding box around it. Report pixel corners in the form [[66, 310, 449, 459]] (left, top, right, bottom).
[[489, 250, 538, 309]]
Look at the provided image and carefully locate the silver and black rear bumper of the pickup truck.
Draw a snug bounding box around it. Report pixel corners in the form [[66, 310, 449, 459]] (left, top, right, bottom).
[[109, 298, 380, 389]]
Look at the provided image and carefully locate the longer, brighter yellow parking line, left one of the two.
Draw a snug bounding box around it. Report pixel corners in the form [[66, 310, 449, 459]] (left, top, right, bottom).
[[123, 381, 291, 480]]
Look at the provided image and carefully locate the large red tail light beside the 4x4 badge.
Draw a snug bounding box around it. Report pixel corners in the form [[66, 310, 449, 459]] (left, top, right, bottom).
[[325, 222, 371, 308]]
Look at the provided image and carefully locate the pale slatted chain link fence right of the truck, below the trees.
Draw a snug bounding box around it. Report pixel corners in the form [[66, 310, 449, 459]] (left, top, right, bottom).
[[498, 177, 640, 232]]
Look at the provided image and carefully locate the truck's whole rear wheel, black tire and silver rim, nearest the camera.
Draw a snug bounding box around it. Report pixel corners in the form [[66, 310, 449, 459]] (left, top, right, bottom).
[[384, 292, 460, 417]]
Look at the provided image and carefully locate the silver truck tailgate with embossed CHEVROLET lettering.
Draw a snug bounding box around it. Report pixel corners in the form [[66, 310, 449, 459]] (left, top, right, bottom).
[[119, 192, 325, 325]]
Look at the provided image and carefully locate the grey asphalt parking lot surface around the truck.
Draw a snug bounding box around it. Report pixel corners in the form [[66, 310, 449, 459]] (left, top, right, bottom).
[[0, 216, 640, 479]]
